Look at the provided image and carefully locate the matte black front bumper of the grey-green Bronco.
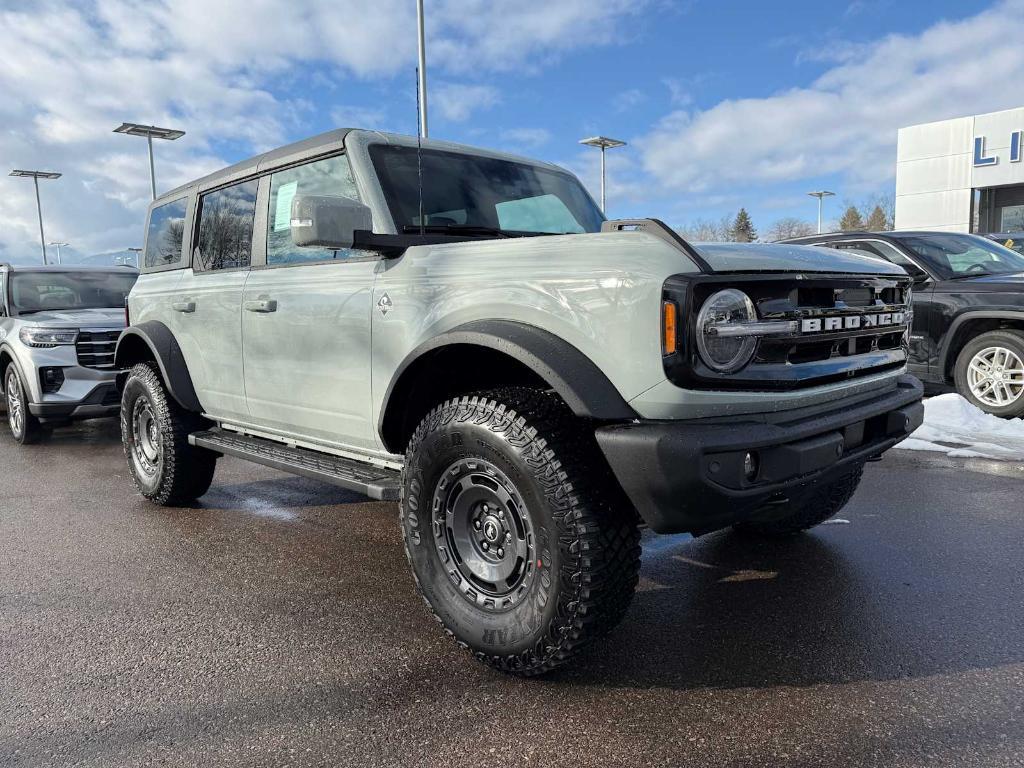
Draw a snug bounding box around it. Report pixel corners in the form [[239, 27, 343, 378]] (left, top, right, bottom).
[[597, 376, 925, 535]]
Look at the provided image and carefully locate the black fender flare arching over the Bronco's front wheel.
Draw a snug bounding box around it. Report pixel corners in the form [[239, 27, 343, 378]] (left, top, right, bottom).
[[377, 319, 637, 448]]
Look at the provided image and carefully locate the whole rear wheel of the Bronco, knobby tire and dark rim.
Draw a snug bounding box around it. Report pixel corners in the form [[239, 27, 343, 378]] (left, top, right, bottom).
[[121, 362, 218, 507]]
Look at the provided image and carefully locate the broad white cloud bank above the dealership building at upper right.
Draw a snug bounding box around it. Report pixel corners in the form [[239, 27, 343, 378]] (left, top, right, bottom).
[[637, 0, 1024, 198]]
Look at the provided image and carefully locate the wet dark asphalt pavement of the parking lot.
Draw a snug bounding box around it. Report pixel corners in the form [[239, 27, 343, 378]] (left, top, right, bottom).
[[0, 421, 1024, 768]]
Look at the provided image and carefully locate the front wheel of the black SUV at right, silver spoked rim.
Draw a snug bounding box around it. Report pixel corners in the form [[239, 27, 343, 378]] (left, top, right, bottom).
[[953, 330, 1024, 419]]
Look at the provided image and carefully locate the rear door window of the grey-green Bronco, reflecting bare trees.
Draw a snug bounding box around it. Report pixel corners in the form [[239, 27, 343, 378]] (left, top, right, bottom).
[[193, 179, 259, 271]]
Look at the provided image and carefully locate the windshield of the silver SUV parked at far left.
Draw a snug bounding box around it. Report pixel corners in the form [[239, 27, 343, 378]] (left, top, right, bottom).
[[10, 269, 138, 314]]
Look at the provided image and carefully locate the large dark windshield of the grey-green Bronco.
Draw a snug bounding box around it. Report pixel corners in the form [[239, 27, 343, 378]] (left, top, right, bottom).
[[370, 144, 604, 234]]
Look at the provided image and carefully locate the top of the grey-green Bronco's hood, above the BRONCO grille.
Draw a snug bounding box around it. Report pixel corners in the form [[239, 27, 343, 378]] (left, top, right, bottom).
[[690, 243, 906, 275]]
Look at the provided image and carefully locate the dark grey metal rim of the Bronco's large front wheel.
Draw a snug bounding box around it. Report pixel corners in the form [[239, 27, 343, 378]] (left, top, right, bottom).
[[432, 459, 537, 610]]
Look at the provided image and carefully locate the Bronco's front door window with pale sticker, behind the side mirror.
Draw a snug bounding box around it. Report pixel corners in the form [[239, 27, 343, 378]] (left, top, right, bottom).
[[266, 155, 367, 265]]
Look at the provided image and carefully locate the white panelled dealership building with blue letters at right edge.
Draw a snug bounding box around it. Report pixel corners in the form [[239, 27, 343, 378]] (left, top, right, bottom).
[[896, 106, 1024, 232]]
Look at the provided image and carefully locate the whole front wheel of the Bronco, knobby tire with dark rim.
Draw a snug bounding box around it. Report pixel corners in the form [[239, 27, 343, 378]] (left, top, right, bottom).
[[399, 388, 640, 676]]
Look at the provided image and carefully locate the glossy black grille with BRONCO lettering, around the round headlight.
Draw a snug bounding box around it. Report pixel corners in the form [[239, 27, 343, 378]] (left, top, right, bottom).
[[665, 274, 912, 390]]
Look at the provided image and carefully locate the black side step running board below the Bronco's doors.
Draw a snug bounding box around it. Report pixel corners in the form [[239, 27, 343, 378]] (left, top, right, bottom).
[[188, 429, 401, 502]]
